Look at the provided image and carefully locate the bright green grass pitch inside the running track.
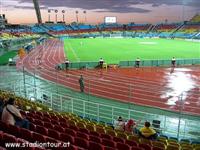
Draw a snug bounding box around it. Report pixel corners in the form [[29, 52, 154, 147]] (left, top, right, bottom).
[[64, 38, 200, 64]]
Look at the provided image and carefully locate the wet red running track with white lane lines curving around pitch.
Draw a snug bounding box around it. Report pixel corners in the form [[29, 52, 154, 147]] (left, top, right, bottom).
[[17, 39, 200, 115]]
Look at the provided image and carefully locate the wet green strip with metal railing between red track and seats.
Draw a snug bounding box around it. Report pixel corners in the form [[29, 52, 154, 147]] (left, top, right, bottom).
[[0, 66, 200, 140]]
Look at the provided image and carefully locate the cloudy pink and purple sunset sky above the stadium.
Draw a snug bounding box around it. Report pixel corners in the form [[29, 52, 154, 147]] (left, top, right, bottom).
[[0, 0, 200, 24]]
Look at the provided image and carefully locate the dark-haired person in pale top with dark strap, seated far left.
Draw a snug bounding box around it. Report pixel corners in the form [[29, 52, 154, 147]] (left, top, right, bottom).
[[1, 98, 29, 129]]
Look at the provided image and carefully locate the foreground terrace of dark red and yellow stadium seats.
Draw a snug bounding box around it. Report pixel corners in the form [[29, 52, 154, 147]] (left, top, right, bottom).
[[0, 91, 200, 150]]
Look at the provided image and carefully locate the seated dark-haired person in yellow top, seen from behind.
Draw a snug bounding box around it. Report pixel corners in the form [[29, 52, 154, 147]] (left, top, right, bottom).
[[139, 121, 157, 140]]
